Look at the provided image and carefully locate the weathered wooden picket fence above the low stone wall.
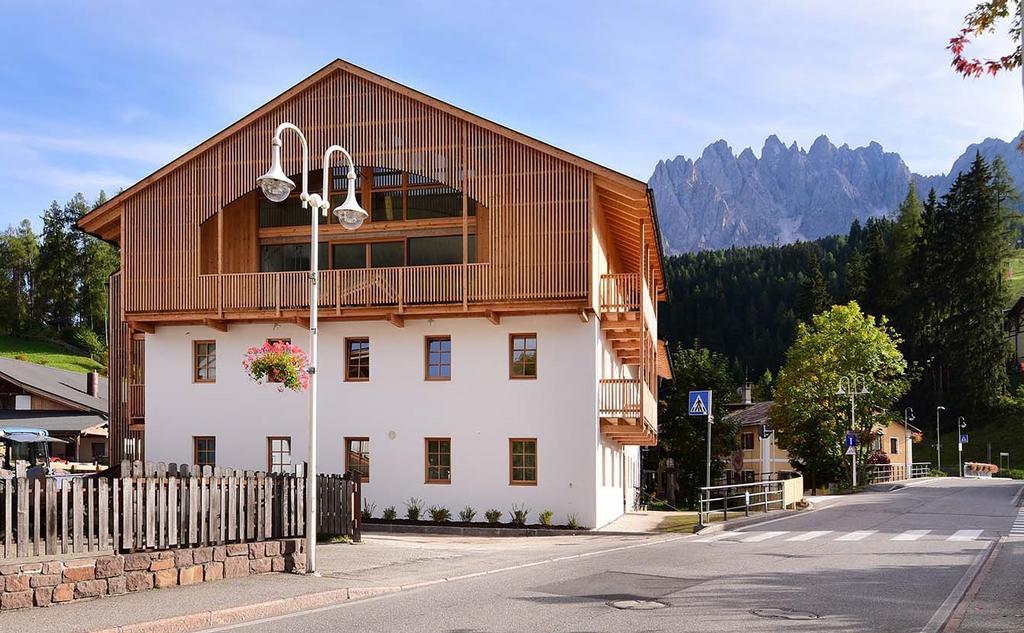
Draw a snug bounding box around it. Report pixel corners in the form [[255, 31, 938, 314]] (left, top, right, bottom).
[[0, 461, 359, 559]]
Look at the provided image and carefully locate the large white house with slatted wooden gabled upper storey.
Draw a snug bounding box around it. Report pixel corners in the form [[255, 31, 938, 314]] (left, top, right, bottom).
[[79, 60, 668, 526]]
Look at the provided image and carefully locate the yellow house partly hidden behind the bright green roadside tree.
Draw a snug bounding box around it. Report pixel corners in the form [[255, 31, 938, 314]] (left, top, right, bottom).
[[726, 385, 921, 483]]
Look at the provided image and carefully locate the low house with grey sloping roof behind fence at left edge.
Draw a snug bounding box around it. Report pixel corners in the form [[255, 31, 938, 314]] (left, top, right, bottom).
[[0, 357, 108, 464]]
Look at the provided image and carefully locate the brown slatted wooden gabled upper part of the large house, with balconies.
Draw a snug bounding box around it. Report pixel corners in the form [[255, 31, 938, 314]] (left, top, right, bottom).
[[79, 59, 665, 460]]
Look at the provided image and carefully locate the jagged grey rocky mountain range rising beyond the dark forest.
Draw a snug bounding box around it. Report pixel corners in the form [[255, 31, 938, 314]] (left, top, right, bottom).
[[648, 134, 1024, 254]]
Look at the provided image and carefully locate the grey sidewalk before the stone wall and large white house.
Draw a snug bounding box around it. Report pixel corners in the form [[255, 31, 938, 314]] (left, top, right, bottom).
[[0, 535, 664, 633]]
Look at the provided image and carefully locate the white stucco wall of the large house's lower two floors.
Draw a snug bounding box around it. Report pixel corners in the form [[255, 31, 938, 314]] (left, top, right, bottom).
[[145, 314, 614, 526]]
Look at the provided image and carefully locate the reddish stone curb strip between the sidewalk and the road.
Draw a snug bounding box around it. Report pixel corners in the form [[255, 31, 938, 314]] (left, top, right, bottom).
[[89, 587, 403, 633]]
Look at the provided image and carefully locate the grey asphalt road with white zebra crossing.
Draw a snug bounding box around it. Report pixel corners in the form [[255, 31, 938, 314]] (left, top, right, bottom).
[[201, 479, 1024, 633]]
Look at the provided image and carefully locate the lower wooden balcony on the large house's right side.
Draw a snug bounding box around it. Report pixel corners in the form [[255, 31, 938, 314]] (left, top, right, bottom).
[[598, 378, 657, 447]]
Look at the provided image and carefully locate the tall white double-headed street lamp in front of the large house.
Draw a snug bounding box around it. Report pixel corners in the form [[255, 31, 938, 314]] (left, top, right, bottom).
[[256, 123, 369, 574]]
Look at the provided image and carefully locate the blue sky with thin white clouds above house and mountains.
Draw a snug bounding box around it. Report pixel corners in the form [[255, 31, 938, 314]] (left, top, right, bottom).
[[0, 0, 1022, 227]]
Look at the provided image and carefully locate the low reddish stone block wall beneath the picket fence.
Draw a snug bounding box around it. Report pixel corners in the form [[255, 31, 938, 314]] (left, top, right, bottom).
[[0, 539, 306, 610]]
